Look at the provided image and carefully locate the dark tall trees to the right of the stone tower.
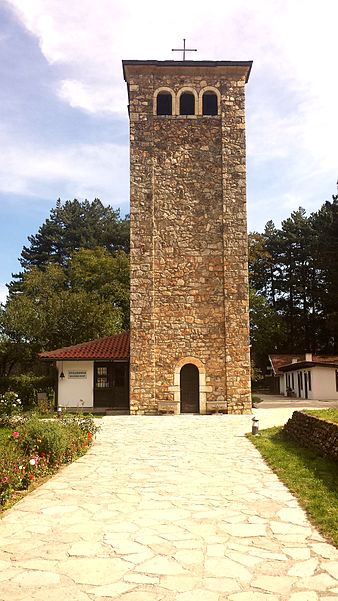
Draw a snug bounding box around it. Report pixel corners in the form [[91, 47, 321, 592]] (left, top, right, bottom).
[[249, 196, 338, 366]]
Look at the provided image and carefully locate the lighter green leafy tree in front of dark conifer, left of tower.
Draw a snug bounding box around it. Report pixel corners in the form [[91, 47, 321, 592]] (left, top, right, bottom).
[[1, 248, 129, 351]]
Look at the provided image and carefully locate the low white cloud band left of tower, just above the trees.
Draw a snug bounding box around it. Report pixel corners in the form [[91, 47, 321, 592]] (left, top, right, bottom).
[[0, 125, 129, 206]]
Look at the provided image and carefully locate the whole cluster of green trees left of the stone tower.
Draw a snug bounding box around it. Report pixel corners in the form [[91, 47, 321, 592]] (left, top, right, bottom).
[[0, 199, 129, 375]]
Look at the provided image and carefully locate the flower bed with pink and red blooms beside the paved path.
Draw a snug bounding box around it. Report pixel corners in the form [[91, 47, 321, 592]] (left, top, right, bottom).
[[0, 416, 98, 506]]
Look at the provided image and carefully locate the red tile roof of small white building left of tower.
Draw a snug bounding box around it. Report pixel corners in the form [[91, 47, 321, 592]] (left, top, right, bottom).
[[39, 332, 130, 360]]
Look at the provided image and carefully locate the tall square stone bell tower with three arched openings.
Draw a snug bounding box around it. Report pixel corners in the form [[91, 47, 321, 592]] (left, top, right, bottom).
[[123, 60, 251, 413]]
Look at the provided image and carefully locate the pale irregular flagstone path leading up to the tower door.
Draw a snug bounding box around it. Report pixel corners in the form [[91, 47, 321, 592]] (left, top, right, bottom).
[[0, 410, 338, 601]]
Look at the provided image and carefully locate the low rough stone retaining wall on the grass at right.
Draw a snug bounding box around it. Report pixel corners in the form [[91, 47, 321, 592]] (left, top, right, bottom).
[[284, 411, 338, 460]]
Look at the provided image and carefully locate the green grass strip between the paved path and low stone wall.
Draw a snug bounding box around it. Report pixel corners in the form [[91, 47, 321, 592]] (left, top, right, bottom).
[[247, 424, 338, 547]]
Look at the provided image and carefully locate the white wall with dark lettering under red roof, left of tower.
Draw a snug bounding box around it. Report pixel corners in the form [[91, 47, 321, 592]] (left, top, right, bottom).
[[56, 361, 94, 408]]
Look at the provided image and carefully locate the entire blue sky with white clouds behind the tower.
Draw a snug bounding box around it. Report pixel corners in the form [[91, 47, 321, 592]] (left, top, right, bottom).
[[0, 0, 338, 300]]
